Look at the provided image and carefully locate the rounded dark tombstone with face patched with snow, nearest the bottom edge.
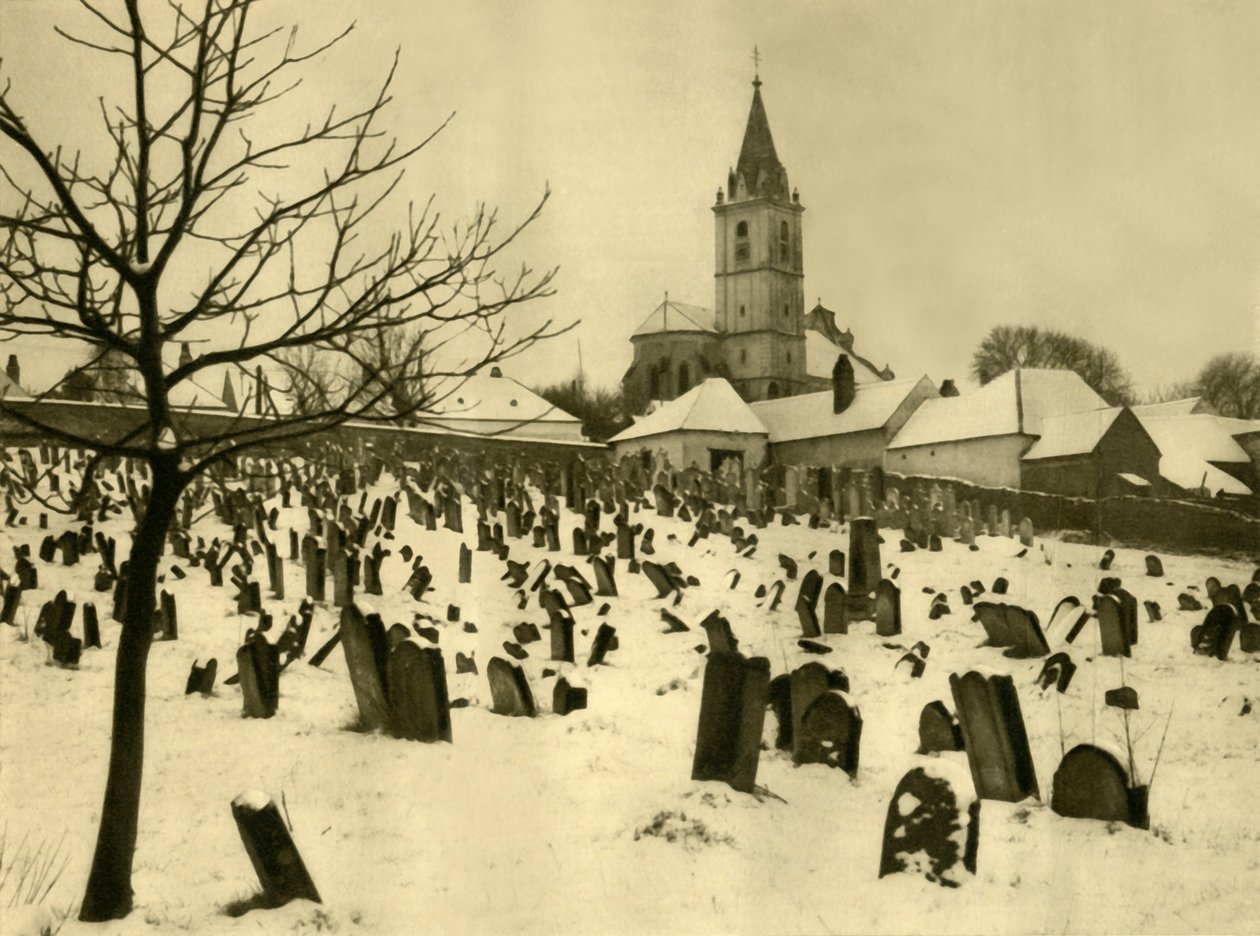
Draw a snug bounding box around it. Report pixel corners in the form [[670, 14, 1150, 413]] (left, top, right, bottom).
[[879, 763, 980, 887]]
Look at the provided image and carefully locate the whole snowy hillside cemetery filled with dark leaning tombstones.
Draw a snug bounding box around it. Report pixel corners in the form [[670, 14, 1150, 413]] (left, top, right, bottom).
[[0, 440, 1260, 933]]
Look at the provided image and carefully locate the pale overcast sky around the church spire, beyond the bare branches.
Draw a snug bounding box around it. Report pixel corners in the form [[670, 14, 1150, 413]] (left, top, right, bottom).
[[0, 0, 1260, 391]]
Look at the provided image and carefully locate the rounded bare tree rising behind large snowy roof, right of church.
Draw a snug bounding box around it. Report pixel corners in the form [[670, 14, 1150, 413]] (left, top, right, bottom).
[[971, 325, 1134, 406]]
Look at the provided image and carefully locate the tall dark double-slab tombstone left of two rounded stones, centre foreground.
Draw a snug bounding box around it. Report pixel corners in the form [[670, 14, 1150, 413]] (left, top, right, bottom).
[[692, 654, 770, 792]]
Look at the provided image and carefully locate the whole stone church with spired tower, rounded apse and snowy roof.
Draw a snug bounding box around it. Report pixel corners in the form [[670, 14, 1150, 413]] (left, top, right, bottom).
[[621, 76, 895, 403]]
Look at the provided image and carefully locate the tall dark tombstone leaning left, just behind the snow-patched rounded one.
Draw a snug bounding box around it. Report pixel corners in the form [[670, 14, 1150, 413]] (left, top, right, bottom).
[[949, 670, 1040, 802]]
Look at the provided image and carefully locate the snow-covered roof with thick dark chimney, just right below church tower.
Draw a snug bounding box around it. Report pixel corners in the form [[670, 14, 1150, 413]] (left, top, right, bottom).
[[752, 375, 935, 442]]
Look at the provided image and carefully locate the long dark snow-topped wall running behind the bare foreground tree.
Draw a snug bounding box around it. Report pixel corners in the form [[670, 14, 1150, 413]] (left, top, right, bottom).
[[0, 401, 607, 464]]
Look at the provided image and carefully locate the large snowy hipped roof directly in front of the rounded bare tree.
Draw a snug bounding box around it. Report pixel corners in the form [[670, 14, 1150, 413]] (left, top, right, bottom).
[[888, 368, 1106, 448]]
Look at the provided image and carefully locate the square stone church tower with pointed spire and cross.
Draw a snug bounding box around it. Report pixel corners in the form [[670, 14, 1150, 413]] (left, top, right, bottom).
[[713, 68, 810, 401]]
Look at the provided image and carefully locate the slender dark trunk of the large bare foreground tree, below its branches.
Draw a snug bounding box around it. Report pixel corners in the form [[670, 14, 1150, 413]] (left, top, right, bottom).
[[79, 456, 184, 922]]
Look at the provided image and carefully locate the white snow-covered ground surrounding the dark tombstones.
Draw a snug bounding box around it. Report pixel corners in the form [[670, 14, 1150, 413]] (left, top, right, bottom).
[[0, 479, 1260, 935]]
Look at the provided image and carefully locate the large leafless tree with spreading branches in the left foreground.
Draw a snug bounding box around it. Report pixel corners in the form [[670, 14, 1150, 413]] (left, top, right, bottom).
[[0, 0, 558, 921]]
